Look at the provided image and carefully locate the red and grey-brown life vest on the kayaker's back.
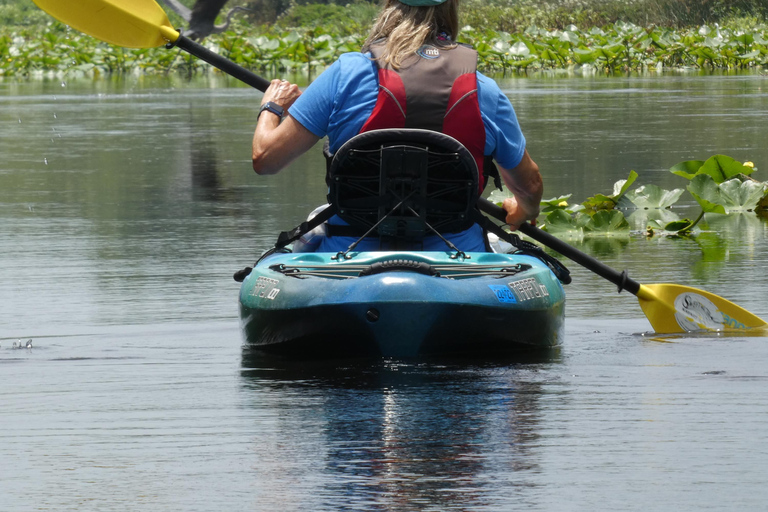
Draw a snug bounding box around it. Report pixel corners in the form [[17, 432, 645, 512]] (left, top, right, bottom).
[[360, 44, 498, 192]]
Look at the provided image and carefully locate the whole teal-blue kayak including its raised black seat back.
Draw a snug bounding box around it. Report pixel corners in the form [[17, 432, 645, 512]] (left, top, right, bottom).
[[236, 130, 570, 358]]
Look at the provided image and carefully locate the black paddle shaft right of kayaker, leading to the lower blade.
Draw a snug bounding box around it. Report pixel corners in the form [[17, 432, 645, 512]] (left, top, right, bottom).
[[477, 197, 640, 295]]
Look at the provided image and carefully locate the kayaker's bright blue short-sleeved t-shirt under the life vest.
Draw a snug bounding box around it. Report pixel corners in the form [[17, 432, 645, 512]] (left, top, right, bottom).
[[288, 52, 525, 252]]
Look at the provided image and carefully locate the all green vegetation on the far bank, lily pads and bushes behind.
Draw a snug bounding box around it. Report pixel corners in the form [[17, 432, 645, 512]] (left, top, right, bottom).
[[0, 0, 768, 78]]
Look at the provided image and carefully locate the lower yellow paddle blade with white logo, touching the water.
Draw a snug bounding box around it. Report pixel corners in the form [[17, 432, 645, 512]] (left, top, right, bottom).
[[637, 284, 768, 333]]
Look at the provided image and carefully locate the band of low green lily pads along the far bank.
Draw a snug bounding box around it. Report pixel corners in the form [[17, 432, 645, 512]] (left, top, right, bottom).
[[0, 17, 768, 76]]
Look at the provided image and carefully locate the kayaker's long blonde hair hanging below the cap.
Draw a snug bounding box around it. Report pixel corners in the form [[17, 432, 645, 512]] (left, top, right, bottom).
[[363, 0, 459, 69]]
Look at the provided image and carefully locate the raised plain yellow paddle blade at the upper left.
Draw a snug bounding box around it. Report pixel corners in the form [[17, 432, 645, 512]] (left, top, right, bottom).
[[34, 0, 179, 48]]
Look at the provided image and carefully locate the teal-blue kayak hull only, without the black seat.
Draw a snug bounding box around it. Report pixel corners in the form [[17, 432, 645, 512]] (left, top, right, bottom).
[[240, 252, 565, 357]]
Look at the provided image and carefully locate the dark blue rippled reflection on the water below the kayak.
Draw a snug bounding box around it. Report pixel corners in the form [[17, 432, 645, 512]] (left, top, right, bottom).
[[241, 351, 559, 510]]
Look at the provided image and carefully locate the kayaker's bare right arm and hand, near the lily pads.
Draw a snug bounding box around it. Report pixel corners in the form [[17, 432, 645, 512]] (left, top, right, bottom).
[[499, 150, 544, 231]]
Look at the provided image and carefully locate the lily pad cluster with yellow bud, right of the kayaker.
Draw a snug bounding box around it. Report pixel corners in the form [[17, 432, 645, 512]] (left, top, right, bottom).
[[490, 155, 768, 236]]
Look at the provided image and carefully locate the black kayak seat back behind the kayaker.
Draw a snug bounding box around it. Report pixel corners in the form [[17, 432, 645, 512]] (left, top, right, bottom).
[[327, 129, 479, 241]]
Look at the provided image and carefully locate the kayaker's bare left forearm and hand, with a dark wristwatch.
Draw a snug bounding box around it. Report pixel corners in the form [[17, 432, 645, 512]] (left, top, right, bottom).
[[251, 80, 320, 174]]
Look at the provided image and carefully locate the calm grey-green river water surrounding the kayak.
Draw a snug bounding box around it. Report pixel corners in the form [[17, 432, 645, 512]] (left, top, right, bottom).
[[0, 73, 768, 511]]
